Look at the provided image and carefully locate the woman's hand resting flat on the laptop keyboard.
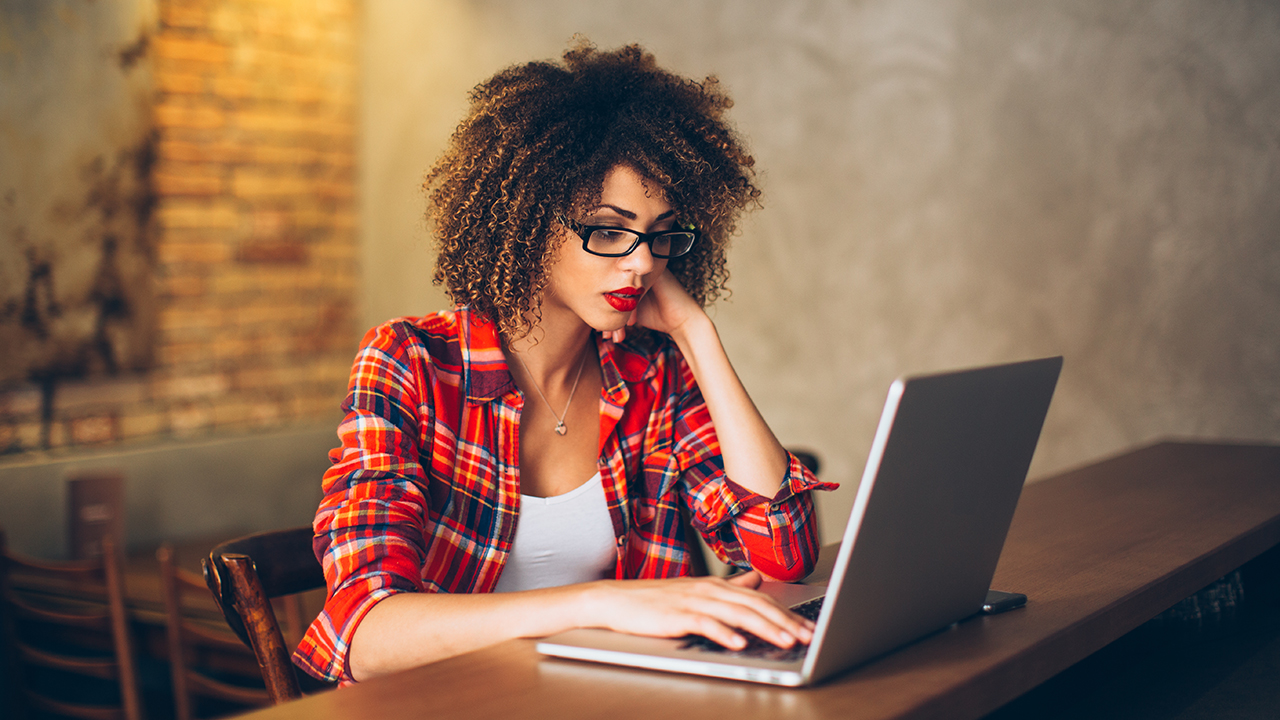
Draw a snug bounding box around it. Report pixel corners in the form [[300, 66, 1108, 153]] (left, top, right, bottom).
[[582, 570, 813, 650]]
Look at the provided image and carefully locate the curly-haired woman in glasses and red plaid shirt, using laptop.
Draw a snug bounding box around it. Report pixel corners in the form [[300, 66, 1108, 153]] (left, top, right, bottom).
[[294, 45, 831, 682]]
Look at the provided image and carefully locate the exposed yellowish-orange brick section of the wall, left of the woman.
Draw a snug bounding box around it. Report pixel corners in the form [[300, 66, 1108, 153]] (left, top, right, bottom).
[[0, 0, 358, 454]]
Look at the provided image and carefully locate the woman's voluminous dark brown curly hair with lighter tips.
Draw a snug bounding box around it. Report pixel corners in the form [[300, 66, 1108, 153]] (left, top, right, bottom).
[[425, 41, 760, 338]]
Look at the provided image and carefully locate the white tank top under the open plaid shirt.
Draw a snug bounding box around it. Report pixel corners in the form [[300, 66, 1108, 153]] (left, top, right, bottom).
[[494, 473, 618, 592]]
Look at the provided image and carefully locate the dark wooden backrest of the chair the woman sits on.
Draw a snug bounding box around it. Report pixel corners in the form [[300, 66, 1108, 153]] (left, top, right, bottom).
[[204, 525, 325, 703]]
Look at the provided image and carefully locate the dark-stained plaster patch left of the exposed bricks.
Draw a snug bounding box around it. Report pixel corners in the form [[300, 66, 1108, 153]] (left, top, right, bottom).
[[0, 0, 156, 386]]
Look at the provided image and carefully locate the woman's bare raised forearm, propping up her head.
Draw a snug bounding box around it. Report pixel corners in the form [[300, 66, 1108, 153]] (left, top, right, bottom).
[[671, 314, 787, 497]]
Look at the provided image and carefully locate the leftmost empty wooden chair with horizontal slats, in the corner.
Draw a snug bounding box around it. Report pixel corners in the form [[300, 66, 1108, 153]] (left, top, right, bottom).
[[0, 532, 143, 720]]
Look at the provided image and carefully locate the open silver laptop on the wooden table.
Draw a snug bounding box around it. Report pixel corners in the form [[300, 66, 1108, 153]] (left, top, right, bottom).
[[538, 357, 1062, 685]]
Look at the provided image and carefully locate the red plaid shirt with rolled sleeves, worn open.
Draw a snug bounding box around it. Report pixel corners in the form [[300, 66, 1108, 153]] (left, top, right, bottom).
[[293, 309, 835, 682]]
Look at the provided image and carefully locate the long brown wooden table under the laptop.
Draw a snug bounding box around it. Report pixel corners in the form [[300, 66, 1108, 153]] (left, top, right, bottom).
[[232, 443, 1280, 720]]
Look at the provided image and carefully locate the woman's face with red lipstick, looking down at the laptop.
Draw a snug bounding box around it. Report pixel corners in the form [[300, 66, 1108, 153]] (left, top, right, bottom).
[[541, 165, 676, 331]]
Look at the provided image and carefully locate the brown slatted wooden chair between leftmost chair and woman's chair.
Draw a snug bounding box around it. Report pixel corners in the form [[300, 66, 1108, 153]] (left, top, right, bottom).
[[156, 543, 271, 720]]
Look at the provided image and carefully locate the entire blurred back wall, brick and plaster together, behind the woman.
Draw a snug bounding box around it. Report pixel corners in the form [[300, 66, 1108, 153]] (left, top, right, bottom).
[[0, 0, 1280, 555]]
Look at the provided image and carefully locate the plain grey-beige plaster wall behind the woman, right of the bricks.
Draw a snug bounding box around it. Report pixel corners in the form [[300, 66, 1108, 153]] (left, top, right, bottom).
[[361, 0, 1280, 539]]
